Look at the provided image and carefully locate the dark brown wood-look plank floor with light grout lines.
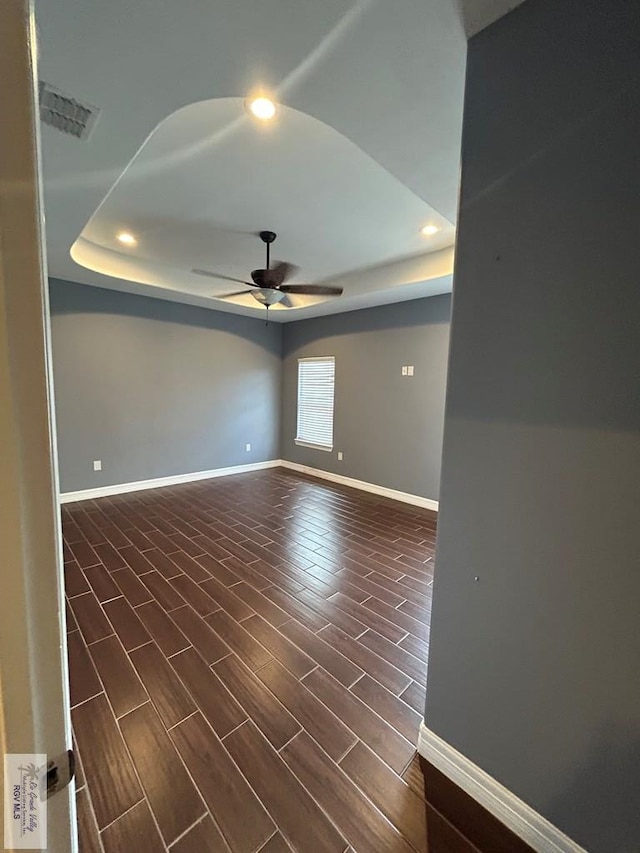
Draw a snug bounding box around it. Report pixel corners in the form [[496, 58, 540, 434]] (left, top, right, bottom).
[[62, 469, 436, 853]]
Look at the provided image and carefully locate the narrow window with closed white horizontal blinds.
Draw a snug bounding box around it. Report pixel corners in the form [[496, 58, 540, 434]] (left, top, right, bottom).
[[296, 355, 336, 450]]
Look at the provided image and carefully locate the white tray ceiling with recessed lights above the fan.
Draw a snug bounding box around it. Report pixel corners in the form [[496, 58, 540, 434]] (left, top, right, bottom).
[[36, 0, 515, 321]]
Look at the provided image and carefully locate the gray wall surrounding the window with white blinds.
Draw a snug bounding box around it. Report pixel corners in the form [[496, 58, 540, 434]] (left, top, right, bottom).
[[281, 294, 451, 500]]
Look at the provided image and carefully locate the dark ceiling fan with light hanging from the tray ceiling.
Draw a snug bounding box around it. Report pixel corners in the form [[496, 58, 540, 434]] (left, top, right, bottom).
[[191, 231, 342, 310]]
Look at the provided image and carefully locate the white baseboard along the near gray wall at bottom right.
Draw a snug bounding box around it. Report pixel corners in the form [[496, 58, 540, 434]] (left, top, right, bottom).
[[418, 723, 587, 853]]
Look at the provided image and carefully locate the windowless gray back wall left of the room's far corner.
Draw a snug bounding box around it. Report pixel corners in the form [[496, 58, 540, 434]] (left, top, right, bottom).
[[50, 280, 282, 492]]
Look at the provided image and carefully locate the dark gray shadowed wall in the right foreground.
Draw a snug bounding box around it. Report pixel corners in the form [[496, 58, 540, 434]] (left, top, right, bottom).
[[426, 0, 640, 853]]
